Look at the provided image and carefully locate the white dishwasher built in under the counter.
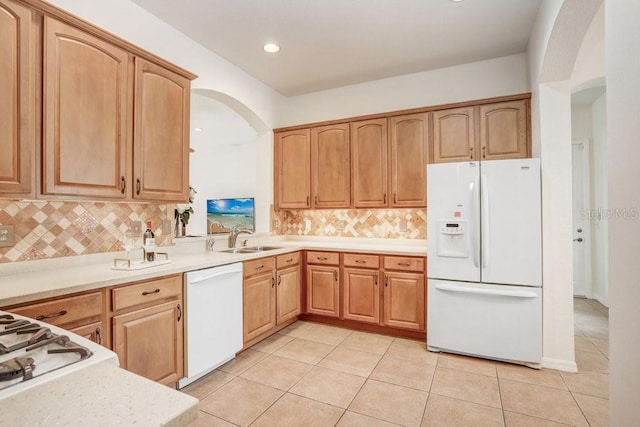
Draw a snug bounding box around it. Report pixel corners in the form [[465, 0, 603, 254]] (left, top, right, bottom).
[[178, 263, 242, 388]]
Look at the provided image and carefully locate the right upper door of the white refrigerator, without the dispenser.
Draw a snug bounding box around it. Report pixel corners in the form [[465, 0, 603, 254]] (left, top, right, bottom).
[[480, 159, 542, 286]]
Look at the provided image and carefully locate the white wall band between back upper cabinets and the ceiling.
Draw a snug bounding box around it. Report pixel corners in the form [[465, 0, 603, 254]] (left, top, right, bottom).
[[277, 54, 529, 127]]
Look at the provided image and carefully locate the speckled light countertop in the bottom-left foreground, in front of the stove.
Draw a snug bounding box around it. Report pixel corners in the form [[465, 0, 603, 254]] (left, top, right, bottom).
[[0, 362, 198, 427]]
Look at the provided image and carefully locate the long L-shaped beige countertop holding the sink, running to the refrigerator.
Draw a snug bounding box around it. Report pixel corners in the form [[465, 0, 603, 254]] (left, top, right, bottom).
[[0, 235, 427, 307]]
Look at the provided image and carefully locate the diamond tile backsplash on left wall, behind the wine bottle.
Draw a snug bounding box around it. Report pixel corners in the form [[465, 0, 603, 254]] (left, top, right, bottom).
[[0, 200, 173, 263]]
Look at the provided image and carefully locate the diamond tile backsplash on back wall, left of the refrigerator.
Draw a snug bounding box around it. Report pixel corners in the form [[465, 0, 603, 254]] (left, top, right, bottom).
[[275, 209, 427, 239]]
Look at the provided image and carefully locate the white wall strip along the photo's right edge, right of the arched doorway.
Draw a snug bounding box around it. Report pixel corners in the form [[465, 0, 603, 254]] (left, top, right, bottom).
[[606, 0, 640, 426]]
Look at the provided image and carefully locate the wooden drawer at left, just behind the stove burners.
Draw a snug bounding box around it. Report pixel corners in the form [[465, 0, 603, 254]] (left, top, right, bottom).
[[9, 292, 102, 326]]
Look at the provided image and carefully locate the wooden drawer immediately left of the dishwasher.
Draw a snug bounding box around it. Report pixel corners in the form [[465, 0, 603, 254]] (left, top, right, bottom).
[[111, 275, 182, 311]]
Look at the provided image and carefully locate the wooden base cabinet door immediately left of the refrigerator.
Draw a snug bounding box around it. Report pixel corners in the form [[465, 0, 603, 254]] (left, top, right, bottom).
[[383, 272, 426, 331]]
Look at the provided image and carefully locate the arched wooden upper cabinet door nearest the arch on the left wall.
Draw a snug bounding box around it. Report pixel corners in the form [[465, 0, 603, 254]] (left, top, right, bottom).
[[133, 58, 191, 202]]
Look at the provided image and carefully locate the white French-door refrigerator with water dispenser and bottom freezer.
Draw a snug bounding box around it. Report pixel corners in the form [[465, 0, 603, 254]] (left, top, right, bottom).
[[427, 159, 542, 365]]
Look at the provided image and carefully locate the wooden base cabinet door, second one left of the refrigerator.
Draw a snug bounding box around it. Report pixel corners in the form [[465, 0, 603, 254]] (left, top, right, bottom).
[[343, 268, 380, 323]]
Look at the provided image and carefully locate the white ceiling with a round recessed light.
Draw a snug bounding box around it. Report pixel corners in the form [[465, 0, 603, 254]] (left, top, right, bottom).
[[133, 0, 542, 96]]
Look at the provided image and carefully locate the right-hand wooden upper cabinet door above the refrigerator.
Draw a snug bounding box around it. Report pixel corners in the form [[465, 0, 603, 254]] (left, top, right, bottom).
[[479, 100, 529, 160]]
